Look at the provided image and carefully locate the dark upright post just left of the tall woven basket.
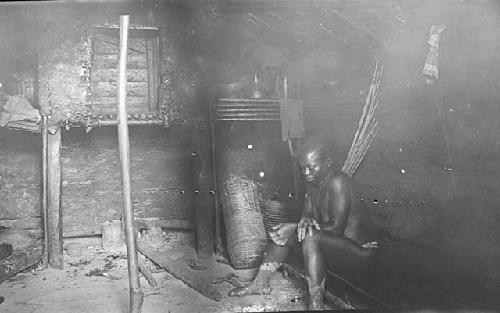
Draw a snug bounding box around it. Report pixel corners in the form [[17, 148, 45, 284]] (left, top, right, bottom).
[[193, 124, 215, 258]]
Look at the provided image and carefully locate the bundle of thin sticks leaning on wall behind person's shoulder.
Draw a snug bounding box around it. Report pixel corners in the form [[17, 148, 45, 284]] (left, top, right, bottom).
[[342, 61, 383, 177]]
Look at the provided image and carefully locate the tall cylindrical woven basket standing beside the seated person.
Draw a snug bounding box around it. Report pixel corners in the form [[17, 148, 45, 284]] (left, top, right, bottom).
[[221, 175, 267, 269]]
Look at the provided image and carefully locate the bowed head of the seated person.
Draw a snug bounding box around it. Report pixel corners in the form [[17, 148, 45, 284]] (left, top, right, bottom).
[[297, 134, 334, 183]]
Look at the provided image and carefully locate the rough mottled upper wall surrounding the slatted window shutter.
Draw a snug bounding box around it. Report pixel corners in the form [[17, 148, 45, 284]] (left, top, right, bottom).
[[33, 2, 203, 126]]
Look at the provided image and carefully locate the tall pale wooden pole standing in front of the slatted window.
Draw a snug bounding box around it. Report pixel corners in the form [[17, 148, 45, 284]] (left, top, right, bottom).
[[118, 15, 144, 313]]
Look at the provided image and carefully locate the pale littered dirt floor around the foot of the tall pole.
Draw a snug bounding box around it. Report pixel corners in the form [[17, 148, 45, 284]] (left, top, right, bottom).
[[0, 241, 332, 313]]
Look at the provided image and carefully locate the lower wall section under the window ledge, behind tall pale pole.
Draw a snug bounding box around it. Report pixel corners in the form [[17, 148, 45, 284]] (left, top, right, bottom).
[[61, 126, 194, 237]]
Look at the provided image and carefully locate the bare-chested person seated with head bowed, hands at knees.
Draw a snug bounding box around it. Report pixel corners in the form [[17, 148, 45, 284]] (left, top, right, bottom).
[[229, 135, 377, 310]]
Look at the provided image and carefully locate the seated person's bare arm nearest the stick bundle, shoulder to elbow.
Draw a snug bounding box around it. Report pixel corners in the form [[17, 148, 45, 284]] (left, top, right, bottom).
[[321, 176, 351, 234]]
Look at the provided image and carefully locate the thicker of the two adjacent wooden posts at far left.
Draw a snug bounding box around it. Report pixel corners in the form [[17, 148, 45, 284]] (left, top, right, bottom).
[[46, 129, 64, 269]]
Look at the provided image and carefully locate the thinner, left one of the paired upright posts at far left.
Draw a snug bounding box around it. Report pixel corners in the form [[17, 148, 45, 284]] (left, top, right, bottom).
[[42, 116, 49, 268]]
